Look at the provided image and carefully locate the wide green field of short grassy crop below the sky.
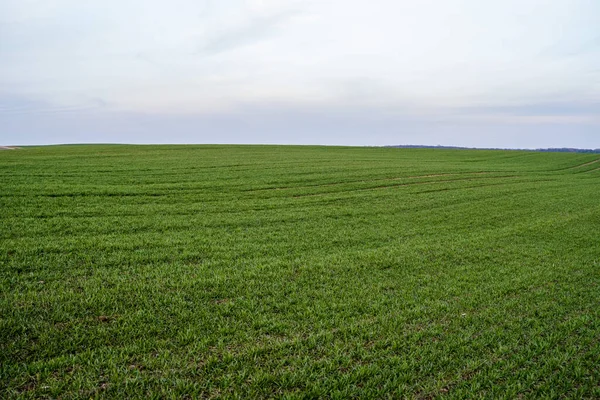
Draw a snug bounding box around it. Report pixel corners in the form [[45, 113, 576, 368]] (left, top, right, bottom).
[[0, 145, 600, 399]]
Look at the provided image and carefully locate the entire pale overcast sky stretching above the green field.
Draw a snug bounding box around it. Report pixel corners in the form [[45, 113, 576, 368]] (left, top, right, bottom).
[[0, 0, 600, 148]]
